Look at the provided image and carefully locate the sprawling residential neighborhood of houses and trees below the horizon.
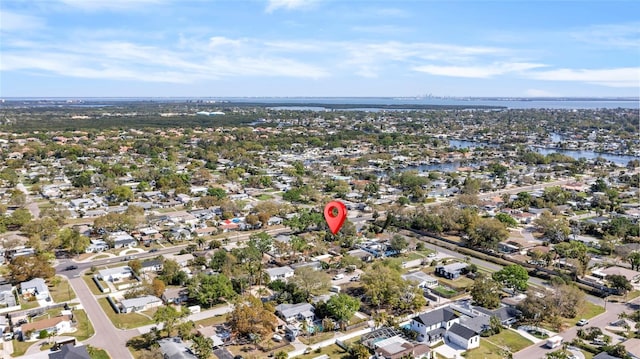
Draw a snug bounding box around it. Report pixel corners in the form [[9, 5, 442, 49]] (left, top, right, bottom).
[[0, 104, 640, 359]]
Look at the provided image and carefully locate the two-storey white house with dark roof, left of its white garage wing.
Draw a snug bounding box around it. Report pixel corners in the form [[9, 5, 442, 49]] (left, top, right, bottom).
[[410, 307, 460, 344]]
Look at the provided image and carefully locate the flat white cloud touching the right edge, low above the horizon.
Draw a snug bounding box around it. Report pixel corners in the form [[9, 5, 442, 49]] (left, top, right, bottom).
[[528, 67, 640, 88]]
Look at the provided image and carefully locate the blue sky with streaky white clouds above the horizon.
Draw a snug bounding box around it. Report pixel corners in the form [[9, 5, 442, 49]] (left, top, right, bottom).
[[0, 0, 640, 97]]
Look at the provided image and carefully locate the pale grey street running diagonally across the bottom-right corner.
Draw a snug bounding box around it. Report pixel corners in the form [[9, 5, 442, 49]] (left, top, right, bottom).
[[513, 298, 640, 359]]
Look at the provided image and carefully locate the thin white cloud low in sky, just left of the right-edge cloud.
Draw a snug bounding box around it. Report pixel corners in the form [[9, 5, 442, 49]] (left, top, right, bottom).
[[413, 62, 545, 79]]
